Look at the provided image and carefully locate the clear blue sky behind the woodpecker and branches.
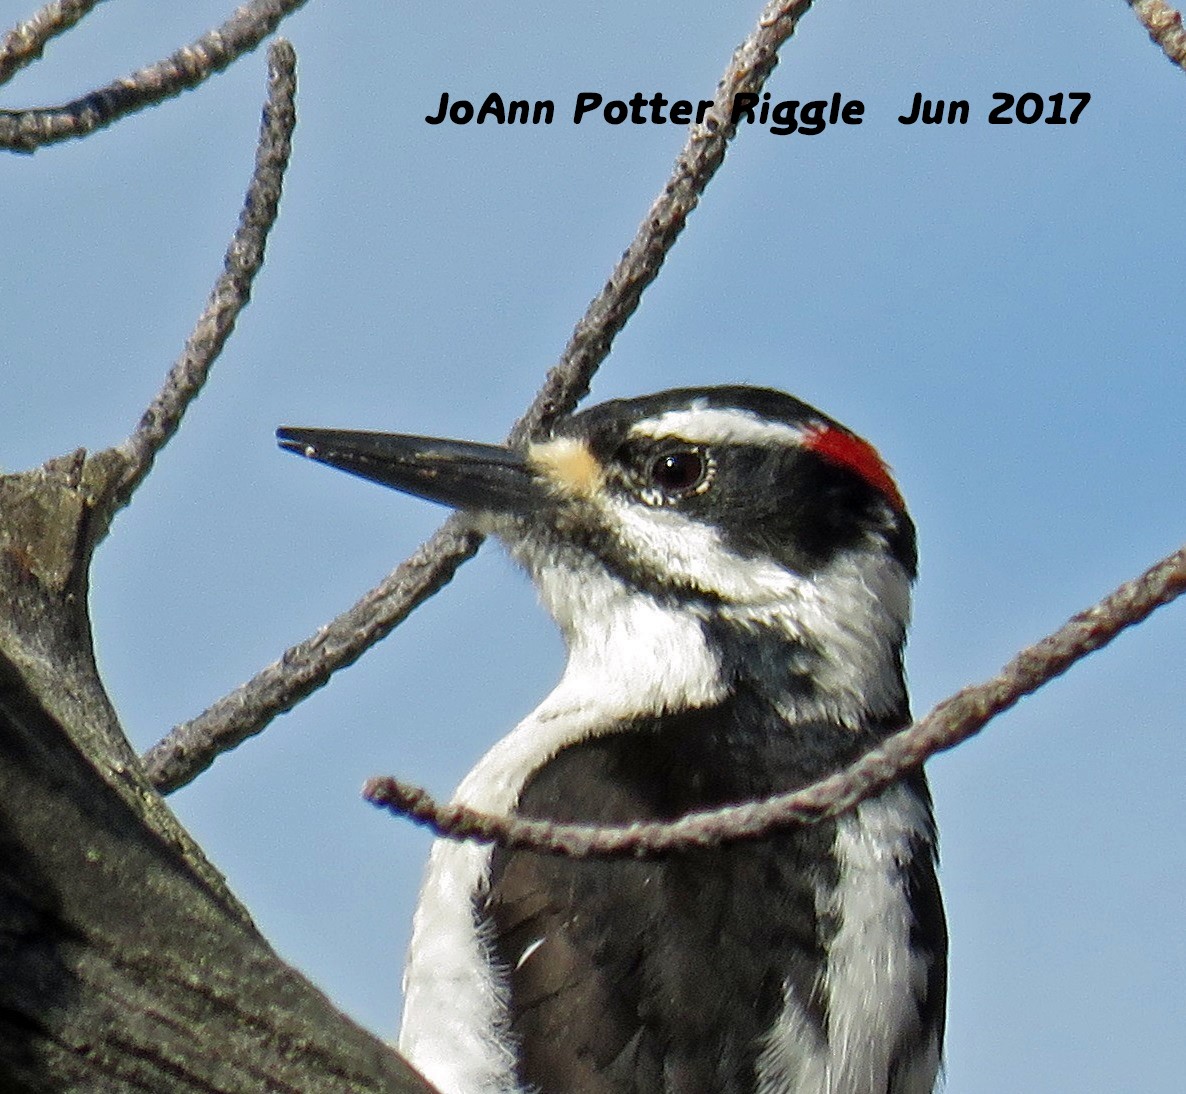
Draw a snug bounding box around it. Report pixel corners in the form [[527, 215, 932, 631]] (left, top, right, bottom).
[[0, 0, 1186, 1094]]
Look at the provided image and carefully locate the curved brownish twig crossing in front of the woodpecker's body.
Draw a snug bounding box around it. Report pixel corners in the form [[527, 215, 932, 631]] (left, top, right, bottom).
[[363, 547, 1186, 858]]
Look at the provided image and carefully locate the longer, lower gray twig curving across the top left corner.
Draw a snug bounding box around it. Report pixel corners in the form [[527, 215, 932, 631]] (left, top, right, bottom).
[[0, 0, 306, 152]]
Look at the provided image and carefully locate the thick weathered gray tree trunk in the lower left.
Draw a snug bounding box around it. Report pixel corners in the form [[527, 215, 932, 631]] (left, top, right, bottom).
[[0, 452, 431, 1094]]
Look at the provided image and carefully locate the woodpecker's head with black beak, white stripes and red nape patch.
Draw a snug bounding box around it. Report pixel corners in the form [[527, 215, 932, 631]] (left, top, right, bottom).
[[278, 387, 917, 723]]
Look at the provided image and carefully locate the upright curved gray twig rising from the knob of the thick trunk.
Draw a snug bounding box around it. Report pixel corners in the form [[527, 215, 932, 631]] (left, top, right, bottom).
[[107, 38, 297, 517]]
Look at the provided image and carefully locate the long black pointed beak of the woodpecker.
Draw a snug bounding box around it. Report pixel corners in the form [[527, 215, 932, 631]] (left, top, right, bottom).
[[276, 427, 546, 515]]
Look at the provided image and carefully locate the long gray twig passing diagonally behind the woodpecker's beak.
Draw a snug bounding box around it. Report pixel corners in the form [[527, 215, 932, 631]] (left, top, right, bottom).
[[145, 0, 811, 793]]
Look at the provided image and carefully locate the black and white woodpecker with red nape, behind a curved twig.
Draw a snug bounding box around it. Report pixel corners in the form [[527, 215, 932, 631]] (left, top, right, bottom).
[[279, 387, 946, 1094]]
